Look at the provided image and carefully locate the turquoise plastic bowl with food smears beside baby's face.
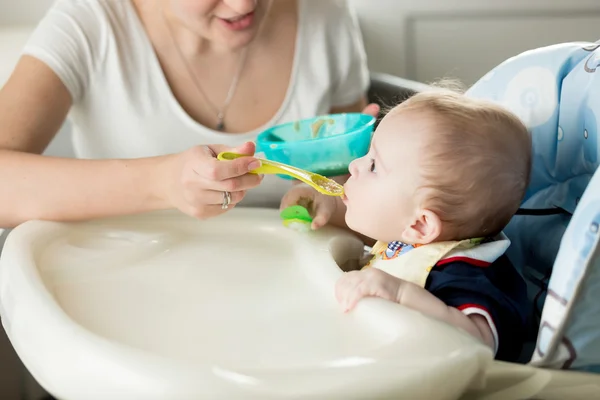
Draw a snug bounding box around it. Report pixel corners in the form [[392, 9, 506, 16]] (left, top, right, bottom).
[[256, 113, 376, 179]]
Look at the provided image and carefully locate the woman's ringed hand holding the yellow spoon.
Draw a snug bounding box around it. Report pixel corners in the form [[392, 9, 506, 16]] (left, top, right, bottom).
[[165, 142, 262, 219]]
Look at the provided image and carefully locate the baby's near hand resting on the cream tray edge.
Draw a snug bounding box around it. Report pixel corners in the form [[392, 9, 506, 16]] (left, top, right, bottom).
[[335, 268, 403, 312]]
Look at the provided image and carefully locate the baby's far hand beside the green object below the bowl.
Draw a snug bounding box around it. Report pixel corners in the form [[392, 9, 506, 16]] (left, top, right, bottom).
[[279, 183, 337, 229]]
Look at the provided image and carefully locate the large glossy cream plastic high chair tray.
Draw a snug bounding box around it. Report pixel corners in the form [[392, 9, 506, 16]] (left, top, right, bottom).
[[0, 209, 492, 400]]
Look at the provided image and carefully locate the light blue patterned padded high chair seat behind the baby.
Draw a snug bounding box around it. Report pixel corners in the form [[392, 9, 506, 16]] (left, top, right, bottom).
[[467, 43, 600, 372]]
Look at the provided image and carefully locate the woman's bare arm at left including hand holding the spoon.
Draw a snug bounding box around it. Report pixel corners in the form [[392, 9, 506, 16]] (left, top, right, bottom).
[[0, 56, 260, 227]]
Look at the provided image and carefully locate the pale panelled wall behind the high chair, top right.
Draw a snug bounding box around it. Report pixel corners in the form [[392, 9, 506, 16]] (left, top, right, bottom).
[[350, 0, 600, 83]]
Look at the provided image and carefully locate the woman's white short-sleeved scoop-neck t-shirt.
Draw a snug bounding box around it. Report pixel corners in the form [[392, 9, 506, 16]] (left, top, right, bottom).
[[24, 0, 369, 207]]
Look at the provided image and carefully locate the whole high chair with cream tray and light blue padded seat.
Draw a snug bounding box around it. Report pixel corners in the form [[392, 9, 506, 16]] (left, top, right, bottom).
[[0, 43, 600, 400]]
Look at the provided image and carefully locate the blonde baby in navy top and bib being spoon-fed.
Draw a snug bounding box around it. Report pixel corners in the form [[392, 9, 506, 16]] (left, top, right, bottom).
[[282, 90, 531, 361]]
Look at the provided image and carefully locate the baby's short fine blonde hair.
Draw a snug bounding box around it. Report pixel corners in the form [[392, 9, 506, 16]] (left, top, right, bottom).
[[394, 88, 531, 240]]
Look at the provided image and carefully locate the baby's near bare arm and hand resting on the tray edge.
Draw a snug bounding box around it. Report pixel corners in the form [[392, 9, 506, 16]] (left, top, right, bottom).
[[336, 268, 496, 349]]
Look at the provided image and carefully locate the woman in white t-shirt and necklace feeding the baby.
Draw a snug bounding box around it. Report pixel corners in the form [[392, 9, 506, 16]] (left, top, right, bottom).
[[0, 0, 378, 227]]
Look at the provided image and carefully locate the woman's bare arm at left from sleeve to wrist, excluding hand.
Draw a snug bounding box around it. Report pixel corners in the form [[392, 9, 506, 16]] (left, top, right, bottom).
[[0, 56, 176, 227]]
